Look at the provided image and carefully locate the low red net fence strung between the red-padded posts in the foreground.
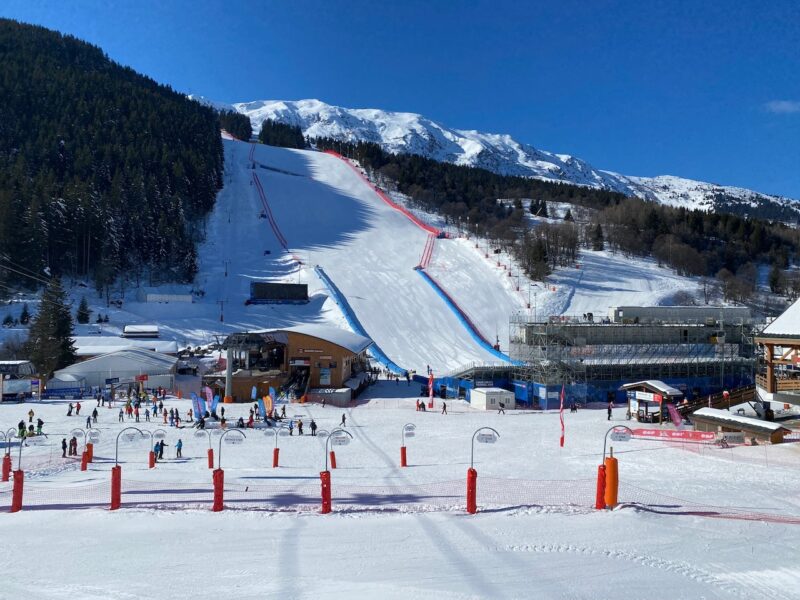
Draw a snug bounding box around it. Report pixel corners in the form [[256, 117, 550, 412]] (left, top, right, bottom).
[[0, 476, 800, 525]]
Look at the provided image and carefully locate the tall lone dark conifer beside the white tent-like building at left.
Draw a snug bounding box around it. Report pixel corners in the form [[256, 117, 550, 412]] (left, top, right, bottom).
[[27, 277, 75, 379]]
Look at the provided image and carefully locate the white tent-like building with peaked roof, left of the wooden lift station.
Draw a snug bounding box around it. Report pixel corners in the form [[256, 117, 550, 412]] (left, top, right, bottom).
[[48, 348, 178, 390]]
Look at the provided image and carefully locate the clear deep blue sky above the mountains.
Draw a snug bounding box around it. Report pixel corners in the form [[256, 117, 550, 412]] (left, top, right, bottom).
[[0, 0, 800, 199]]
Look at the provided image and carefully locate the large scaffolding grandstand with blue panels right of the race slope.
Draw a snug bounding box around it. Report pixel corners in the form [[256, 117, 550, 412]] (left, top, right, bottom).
[[509, 307, 756, 409]]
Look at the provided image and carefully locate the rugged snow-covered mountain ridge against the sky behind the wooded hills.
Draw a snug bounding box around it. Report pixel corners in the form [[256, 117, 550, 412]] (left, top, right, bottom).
[[195, 98, 800, 222]]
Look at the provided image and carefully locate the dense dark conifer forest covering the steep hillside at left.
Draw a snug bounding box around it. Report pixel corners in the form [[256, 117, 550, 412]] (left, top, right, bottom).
[[0, 19, 229, 298]]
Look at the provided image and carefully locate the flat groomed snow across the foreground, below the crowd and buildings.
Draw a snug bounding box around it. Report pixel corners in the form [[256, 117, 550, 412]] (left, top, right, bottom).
[[0, 381, 800, 600]]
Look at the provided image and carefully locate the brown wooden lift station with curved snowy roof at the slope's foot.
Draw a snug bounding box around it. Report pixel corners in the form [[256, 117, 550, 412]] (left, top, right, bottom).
[[203, 325, 372, 401]]
